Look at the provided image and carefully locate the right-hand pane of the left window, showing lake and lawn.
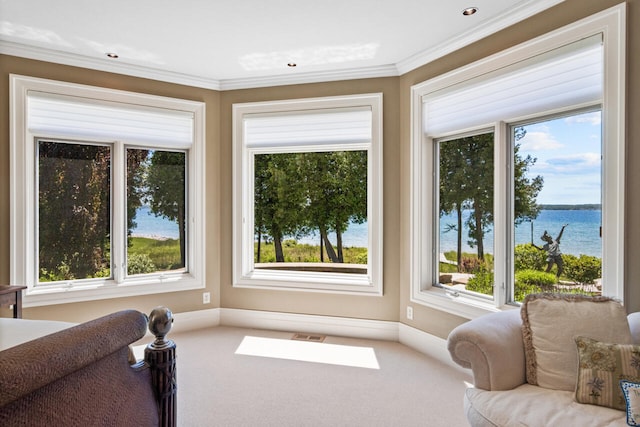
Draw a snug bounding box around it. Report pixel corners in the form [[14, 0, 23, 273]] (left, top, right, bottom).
[[127, 149, 187, 275]]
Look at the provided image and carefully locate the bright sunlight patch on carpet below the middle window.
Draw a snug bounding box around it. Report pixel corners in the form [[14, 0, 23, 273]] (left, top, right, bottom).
[[236, 336, 380, 369]]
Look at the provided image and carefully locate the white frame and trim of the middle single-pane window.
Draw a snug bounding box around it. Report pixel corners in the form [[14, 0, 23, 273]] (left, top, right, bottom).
[[233, 93, 383, 296]]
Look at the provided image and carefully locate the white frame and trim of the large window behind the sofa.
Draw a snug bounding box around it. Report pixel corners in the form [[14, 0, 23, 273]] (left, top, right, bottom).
[[409, 3, 626, 319]]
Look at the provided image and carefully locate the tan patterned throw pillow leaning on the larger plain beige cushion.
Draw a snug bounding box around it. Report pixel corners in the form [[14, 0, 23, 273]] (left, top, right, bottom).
[[576, 337, 640, 411]]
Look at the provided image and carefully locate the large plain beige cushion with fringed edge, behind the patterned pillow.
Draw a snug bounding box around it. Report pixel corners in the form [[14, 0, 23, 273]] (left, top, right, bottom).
[[520, 294, 632, 391]]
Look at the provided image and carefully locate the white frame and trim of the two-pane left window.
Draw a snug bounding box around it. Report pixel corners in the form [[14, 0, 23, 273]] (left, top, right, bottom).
[[9, 75, 205, 307]]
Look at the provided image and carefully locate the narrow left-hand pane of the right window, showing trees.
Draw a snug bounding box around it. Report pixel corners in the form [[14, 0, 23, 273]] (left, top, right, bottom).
[[437, 132, 494, 296]]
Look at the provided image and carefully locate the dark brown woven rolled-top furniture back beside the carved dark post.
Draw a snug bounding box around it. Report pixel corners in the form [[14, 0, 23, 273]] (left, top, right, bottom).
[[0, 310, 175, 427]]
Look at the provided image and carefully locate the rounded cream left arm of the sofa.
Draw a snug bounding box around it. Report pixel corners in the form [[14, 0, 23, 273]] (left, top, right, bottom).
[[447, 310, 526, 390]]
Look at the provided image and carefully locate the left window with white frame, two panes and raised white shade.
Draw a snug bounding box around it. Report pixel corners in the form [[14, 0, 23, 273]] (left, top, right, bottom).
[[11, 76, 204, 305]]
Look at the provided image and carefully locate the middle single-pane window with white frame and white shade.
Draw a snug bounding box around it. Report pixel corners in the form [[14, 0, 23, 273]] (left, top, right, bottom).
[[233, 94, 382, 294]]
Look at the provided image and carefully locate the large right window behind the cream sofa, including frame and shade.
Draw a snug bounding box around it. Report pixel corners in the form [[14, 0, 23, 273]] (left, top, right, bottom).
[[411, 7, 624, 317]]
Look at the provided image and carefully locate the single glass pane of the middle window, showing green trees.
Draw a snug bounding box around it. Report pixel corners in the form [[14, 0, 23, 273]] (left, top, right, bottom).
[[254, 150, 368, 274]]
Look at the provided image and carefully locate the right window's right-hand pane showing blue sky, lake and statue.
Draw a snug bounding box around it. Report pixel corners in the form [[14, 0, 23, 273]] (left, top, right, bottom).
[[513, 111, 602, 301]]
